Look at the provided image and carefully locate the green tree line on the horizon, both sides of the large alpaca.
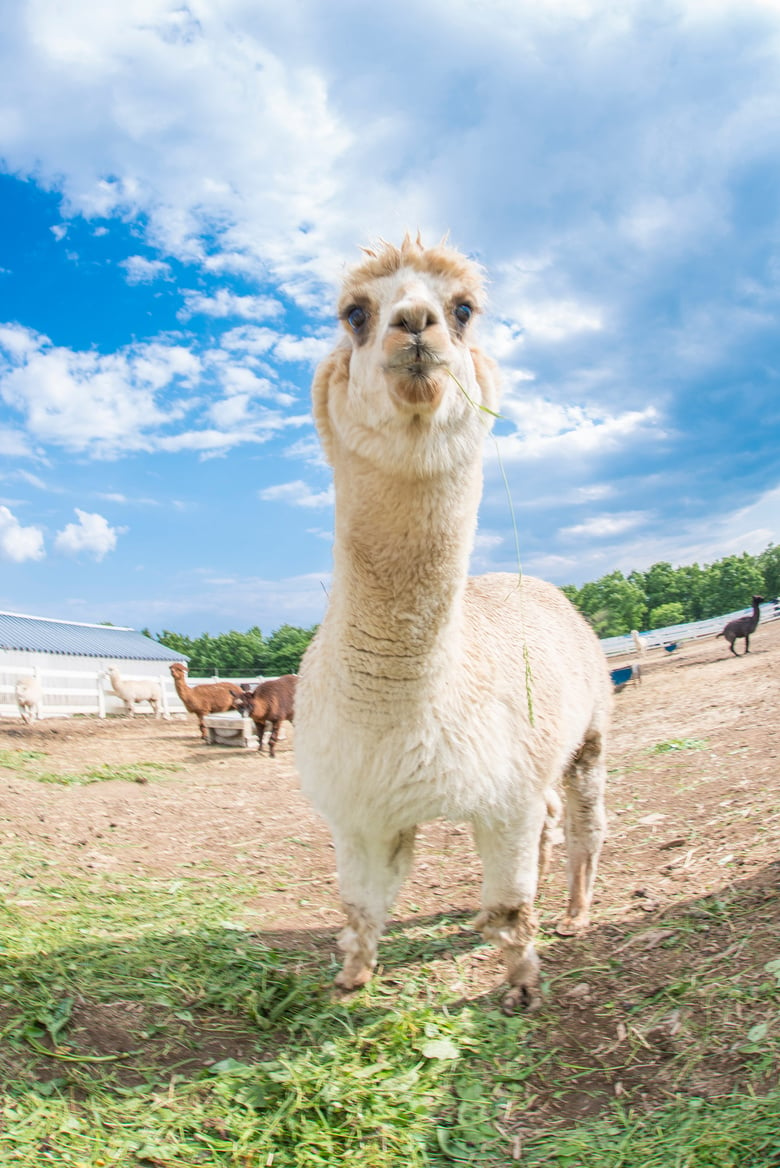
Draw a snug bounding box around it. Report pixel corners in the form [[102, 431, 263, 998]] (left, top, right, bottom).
[[144, 543, 780, 677]]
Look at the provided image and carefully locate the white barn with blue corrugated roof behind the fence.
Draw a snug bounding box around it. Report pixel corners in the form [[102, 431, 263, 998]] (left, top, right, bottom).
[[0, 612, 186, 717]]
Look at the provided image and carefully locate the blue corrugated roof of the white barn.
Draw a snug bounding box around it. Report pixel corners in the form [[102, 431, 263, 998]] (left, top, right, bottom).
[[0, 612, 187, 661]]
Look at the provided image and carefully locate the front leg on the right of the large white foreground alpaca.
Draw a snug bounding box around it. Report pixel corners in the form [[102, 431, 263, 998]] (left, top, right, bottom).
[[474, 812, 549, 1014]]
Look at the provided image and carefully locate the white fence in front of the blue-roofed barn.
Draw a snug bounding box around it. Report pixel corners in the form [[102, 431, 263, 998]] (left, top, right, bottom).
[[0, 666, 264, 718]]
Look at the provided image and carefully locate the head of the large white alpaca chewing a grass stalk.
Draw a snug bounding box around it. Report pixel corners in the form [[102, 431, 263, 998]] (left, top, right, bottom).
[[313, 236, 496, 474]]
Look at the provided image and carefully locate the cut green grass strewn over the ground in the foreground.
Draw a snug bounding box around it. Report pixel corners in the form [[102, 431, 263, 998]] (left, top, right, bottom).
[[0, 854, 780, 1168]]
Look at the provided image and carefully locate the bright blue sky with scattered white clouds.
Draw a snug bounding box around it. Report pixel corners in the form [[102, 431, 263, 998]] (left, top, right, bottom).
[[0, 0, 780, 635]]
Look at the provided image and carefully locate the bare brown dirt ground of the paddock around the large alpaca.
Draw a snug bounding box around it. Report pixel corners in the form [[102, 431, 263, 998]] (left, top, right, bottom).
[[0, 621, 780, 1113]]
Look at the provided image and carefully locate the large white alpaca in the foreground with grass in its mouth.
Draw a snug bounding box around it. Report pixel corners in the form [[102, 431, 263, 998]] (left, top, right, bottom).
[[295, 237, 612, 1011]]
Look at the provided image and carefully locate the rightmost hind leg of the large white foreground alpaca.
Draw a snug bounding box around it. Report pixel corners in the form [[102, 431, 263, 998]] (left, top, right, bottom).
[[556, 731, 606, 937]]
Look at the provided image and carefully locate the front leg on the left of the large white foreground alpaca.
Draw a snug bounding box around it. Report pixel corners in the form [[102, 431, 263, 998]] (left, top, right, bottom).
[[333, 827, 417, 989]]
